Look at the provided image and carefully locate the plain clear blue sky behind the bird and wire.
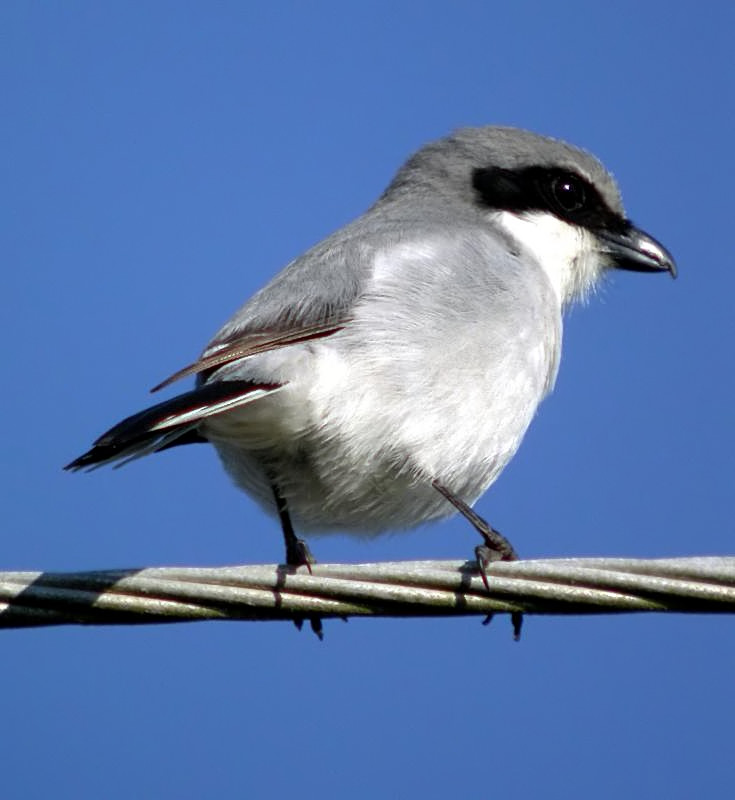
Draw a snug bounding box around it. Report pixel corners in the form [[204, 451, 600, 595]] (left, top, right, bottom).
[[0, 0, 735, 799]]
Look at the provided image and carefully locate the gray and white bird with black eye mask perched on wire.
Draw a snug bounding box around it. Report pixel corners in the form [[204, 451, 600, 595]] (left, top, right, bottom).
[[67, 127, 675, 632]]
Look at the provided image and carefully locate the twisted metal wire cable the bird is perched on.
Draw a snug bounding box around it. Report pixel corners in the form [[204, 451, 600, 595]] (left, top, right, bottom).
[[0, 556, 735, 628]]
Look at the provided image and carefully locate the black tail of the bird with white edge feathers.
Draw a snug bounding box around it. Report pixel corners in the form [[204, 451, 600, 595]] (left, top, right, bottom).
[[64, 381, 281, 471]]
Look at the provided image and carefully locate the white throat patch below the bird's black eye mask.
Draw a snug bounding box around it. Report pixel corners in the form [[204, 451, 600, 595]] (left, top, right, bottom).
[[493, 211, 604, 306]]
